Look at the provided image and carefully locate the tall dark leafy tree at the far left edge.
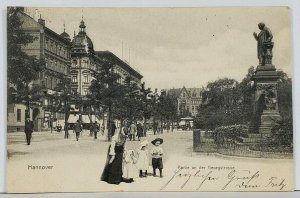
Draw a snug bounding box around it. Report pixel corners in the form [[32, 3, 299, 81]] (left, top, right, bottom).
[[7, 7, 45, 119]]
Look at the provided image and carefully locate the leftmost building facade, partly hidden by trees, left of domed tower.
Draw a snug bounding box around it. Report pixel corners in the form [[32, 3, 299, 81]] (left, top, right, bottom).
[[8, 12, 71, 131]]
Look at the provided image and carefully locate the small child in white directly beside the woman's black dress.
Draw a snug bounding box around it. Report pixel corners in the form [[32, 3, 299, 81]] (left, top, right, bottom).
[[123, 150, 137, 183]]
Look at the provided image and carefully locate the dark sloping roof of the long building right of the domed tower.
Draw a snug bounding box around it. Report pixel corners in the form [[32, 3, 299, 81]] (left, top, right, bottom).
[[95, 51, 143, 80]]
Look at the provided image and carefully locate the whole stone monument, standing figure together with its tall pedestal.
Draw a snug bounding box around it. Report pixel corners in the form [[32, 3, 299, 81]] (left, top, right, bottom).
[[249, 23, 281, 136]]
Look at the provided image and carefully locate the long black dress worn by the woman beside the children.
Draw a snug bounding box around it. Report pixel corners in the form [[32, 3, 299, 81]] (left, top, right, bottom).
[[101, 145, 124, 184]]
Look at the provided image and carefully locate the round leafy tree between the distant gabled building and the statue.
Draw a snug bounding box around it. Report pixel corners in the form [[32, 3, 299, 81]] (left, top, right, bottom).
[[195, 78, 243, 130]]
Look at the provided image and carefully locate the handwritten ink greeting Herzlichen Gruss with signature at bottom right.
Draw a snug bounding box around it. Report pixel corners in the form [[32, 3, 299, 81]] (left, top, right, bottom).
[[160, 165, 287, 191]]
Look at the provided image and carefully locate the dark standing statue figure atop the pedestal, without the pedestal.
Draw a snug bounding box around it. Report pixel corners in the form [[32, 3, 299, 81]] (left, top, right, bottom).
[[253, 23, 274, 66]]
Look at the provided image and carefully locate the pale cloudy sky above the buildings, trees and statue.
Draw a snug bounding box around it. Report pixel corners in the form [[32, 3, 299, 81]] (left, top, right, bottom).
[[27, 7, 292, 90]]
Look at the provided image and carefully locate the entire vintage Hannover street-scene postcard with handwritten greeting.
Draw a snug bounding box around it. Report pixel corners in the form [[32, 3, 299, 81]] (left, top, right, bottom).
[[6, 7, 294, 193]]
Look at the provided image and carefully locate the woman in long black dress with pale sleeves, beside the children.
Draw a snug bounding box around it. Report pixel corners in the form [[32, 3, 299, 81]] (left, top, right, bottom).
[[101, 124, 126, 184]]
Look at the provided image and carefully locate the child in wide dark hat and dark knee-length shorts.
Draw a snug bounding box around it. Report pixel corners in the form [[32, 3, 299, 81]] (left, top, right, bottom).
[[151, 138, 163, 178]]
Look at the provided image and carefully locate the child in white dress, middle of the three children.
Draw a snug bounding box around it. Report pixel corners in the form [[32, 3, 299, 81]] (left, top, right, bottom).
[[137, 140, 149, 177]]
